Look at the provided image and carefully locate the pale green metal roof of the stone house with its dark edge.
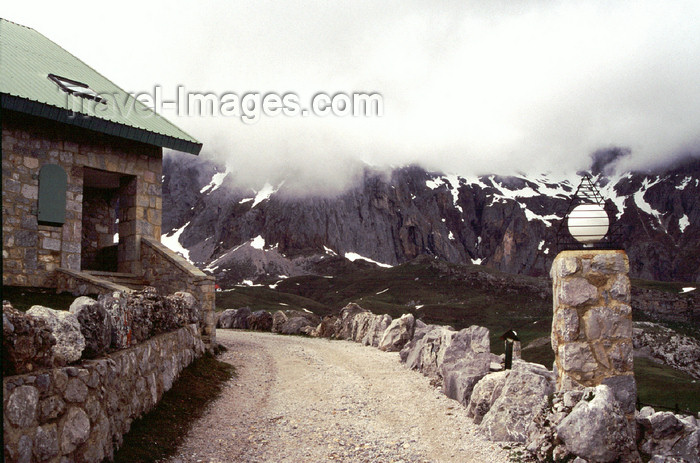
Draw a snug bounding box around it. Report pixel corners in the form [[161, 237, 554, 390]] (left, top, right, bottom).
[[0, 18, 202, 154]]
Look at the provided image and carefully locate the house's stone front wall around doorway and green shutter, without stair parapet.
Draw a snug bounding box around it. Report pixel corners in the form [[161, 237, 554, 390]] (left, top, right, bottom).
[[2, 111, 162, 287]]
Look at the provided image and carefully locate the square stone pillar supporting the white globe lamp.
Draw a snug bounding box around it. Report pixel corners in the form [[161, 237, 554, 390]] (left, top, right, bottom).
[[550, 250, 637, 414]]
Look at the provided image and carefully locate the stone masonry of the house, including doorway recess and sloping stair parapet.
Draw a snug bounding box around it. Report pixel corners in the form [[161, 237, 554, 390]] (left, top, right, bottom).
[[2, 111, 216, 345]]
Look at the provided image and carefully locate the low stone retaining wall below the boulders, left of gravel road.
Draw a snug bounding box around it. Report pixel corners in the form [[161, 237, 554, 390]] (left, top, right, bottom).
[[3, 325, 204, 463]]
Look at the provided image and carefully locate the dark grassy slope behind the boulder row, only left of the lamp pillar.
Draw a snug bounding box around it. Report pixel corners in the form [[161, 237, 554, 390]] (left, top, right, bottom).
[[217, 259, 553, 358]]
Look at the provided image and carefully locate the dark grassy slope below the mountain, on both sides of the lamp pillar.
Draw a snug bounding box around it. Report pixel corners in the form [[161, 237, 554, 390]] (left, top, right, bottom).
[[217, 257, 700, 412]]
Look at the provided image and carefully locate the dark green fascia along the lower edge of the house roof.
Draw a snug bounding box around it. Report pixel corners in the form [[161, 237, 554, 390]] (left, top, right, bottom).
[[0, 93, 202, 156]]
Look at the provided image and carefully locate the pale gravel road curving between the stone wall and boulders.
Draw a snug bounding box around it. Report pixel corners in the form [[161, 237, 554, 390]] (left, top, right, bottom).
[[164, 330, 509, 463]]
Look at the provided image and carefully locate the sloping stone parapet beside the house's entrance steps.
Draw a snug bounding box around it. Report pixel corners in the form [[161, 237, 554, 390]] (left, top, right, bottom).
[[141, 238, 216, 346]]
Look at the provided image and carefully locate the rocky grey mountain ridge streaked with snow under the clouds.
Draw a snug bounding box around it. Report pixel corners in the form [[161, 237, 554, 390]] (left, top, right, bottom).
[[163, 156, 700, 283]]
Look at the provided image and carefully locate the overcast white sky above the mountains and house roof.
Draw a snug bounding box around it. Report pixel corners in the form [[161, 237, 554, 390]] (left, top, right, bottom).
[[5, 0, 700, 192]]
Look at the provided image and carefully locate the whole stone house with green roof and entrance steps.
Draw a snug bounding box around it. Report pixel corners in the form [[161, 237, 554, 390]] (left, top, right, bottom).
[[0, 20, 214, 342]]
